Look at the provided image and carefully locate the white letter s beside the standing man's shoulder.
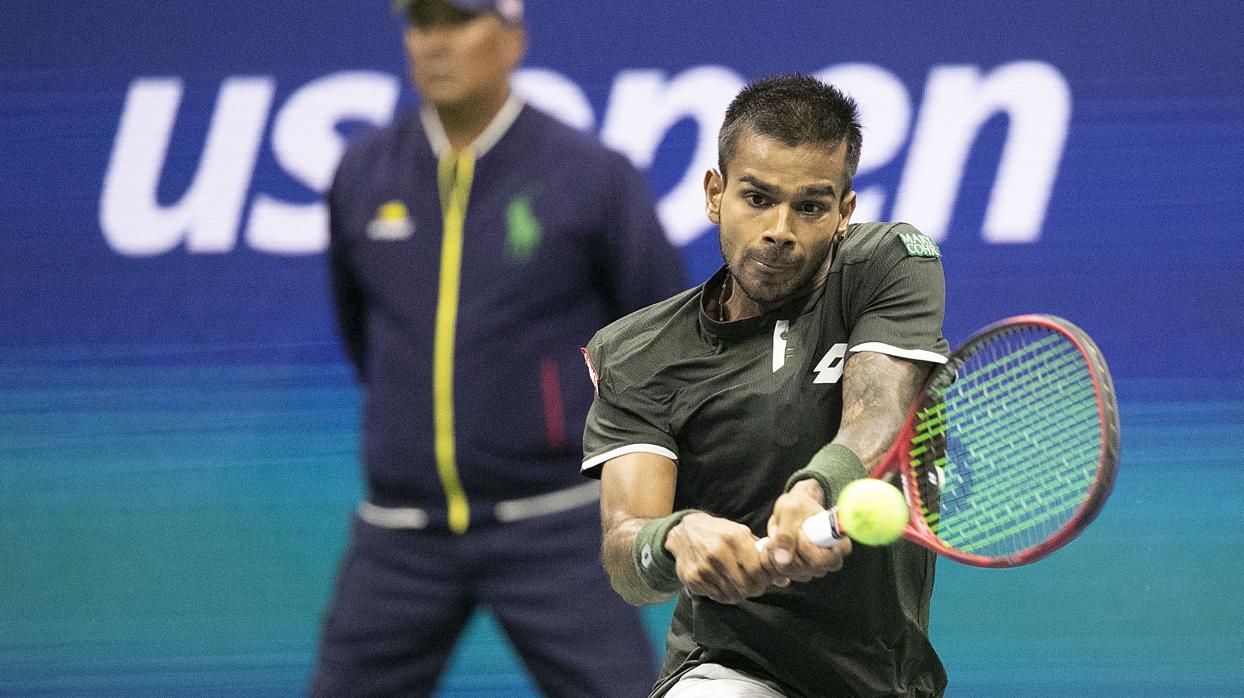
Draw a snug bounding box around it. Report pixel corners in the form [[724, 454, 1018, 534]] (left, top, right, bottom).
[[246, 71, 401, 254]]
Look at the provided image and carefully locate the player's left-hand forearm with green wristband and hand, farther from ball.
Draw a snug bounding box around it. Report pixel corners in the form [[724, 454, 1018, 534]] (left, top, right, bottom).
[[601, 453, 786, 606]]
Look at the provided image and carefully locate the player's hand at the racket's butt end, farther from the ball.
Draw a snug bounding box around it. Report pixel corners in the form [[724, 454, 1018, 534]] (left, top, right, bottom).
[[666, 513, 773, 603]]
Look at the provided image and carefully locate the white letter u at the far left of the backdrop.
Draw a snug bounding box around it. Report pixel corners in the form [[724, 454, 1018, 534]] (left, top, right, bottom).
[[100, 77, 274, 256]]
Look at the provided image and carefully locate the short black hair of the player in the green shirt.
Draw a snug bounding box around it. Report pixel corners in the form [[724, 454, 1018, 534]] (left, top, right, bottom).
[[717, 73, 863, 195]]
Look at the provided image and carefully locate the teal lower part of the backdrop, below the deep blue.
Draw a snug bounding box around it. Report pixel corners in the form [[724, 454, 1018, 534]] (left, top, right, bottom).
[[0, 356, 1244, 698]]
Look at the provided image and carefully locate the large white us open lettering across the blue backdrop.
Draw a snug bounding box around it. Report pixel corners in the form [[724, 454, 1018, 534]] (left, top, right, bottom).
[[100, 61, 1071, 256]]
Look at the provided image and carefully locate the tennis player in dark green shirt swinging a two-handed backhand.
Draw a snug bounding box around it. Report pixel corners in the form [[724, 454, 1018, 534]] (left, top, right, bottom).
[[582, 76, 949, 698]]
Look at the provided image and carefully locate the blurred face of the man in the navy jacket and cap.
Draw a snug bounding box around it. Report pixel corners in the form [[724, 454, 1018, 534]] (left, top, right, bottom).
[[406, 0, 525, 107]]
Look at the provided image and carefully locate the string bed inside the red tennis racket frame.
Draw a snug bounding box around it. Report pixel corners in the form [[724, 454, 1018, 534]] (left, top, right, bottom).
[[912, 327, 1102, 556]]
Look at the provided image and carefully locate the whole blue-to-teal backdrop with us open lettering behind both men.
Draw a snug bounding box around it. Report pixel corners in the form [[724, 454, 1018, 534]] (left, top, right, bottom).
[[0, 0, 1244, 696]]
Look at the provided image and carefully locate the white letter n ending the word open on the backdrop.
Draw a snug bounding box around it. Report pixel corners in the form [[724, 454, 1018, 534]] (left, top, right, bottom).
[[892, 61, 1071, 243]]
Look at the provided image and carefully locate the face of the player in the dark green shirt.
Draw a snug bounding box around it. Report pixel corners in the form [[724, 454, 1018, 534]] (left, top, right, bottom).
[[704, 131, 856, 310]]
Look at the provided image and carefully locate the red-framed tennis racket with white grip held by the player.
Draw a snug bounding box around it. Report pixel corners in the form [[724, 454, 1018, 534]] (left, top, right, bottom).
[[761, 315, 1118, 567]]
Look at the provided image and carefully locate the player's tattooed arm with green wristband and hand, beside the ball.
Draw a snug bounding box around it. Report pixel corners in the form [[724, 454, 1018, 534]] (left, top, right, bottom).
[[768, 351, 929, 581]]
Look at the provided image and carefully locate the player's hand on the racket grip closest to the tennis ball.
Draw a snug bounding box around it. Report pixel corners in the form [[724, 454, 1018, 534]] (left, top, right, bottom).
[[764, 480, 851, 582]]
